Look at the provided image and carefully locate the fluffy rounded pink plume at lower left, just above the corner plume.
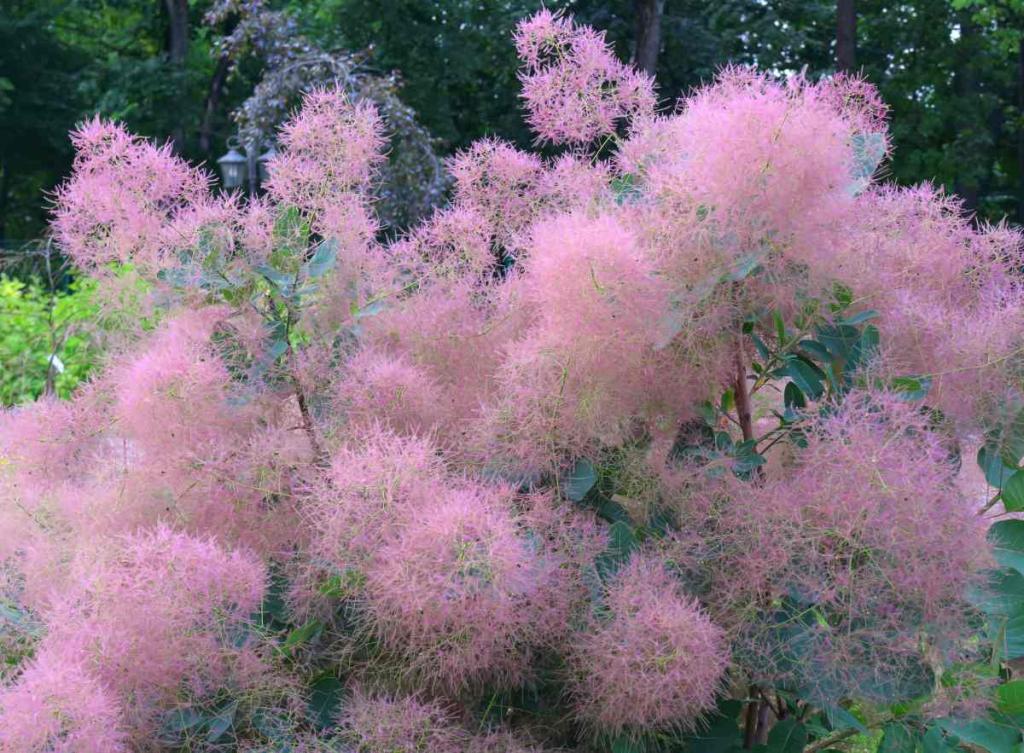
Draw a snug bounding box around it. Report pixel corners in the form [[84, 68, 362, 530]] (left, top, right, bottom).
[[43, 527, 266, 725]]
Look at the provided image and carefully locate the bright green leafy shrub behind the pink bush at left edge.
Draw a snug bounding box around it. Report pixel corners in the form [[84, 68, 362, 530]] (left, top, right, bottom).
[[0, 276, 99, 406]]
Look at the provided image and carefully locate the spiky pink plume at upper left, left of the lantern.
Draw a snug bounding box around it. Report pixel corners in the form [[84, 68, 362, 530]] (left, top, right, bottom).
[[53, 118, 209, 273]]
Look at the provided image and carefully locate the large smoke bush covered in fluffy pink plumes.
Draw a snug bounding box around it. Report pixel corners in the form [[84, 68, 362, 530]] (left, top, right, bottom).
[[0, 11, 1024, 753]]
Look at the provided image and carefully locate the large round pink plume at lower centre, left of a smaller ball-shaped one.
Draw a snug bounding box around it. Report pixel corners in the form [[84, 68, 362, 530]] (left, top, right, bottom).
[[367, 485, 567, 691]]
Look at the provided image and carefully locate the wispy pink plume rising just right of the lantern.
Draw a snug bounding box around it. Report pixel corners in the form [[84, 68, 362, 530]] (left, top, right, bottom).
[[266, 88, 384, 221]]
